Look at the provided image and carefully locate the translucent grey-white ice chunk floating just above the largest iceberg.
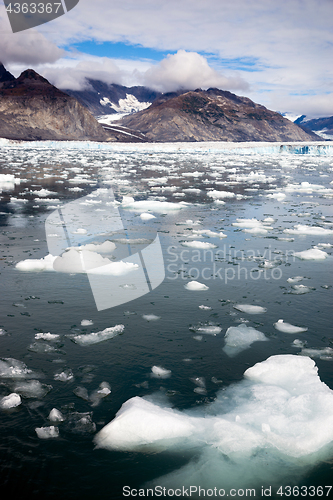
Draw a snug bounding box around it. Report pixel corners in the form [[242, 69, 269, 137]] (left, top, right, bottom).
[[223, 323, 268, 357]]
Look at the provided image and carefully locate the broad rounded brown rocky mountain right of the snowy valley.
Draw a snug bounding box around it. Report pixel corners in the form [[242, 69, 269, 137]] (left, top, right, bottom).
[[118, 89, 320, 142]]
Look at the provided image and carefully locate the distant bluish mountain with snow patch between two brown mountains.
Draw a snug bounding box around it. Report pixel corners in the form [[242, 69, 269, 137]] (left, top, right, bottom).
[[62, 79, 161, 116]]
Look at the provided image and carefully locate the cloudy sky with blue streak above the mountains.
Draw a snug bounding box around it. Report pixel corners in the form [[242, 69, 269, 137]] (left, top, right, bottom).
[[0, 0, 333, 118]]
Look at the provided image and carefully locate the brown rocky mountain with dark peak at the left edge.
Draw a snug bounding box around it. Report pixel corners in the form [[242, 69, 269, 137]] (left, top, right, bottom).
[[0, 64, 111, 141]]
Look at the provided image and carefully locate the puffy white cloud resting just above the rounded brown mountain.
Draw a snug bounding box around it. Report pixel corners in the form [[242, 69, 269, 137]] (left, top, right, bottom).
[[143, 50, 248, 92]]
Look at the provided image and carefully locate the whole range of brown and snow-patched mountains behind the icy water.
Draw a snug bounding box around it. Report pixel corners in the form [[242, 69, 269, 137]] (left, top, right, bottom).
[[0, 63, 321, 142]]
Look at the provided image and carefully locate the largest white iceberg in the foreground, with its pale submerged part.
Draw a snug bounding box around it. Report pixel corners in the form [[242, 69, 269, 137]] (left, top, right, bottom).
[[94, 354, 333, 489]]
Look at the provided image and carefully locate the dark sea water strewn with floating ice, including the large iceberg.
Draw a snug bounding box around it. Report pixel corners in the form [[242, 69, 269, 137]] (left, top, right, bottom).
[[0, 141, 333, 500]]
